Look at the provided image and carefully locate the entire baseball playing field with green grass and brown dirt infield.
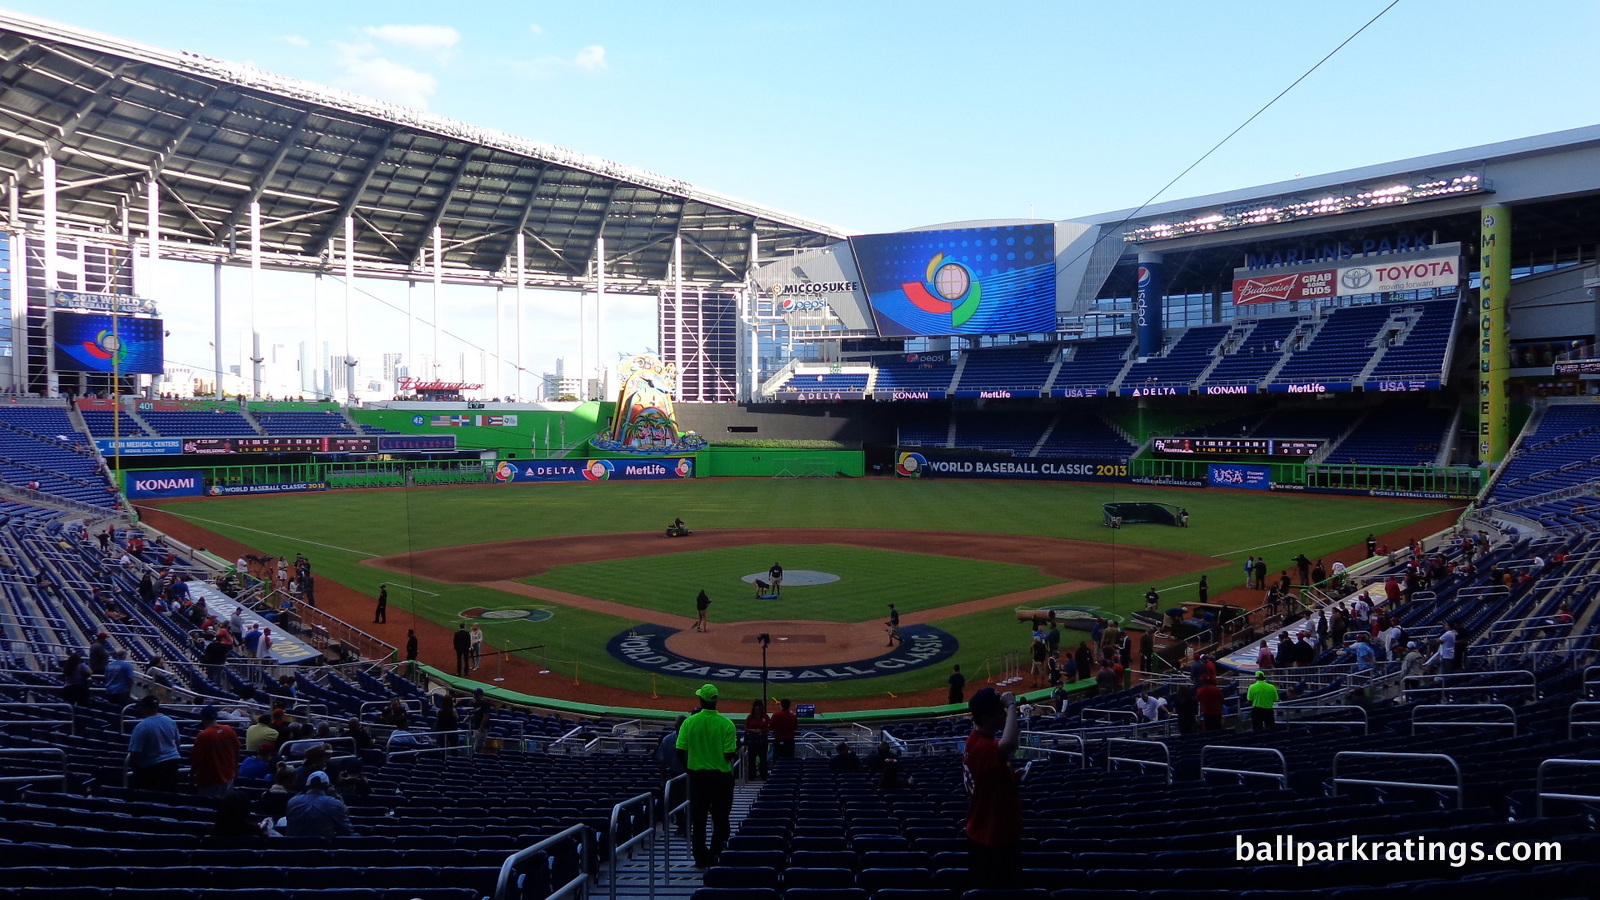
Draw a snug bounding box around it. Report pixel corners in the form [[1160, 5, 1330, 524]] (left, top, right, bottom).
[[141, 479, 1456, 709]]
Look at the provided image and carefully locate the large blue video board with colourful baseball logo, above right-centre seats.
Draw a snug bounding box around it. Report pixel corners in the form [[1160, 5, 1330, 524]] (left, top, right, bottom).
[[850, 224, 1056, 338]]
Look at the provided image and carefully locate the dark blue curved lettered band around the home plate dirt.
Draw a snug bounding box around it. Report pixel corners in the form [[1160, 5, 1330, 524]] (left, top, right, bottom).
[[606, 625, 958, 684]]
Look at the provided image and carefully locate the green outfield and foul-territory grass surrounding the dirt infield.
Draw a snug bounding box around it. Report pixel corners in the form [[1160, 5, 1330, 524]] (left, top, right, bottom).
[[150, 479, 1465, 700]]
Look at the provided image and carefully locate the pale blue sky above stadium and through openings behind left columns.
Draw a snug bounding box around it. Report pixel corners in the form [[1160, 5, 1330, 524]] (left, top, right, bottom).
[[8, 0, 1600, 392]]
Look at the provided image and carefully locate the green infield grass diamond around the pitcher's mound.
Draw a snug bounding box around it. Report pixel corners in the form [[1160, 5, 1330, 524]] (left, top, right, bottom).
[[520, 544, 1059, 621]]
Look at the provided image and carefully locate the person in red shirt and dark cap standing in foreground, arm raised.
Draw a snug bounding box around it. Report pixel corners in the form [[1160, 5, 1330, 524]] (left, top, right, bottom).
[[962, 687, 1022, 887]]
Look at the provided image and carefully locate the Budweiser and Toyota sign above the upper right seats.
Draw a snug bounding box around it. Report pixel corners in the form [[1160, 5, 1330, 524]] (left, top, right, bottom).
[[1234, 243, 1461, 306]]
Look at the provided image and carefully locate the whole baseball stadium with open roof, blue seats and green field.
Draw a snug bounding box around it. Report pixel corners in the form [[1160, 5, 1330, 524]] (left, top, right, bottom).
[[0, 13, 1600, 900]]
